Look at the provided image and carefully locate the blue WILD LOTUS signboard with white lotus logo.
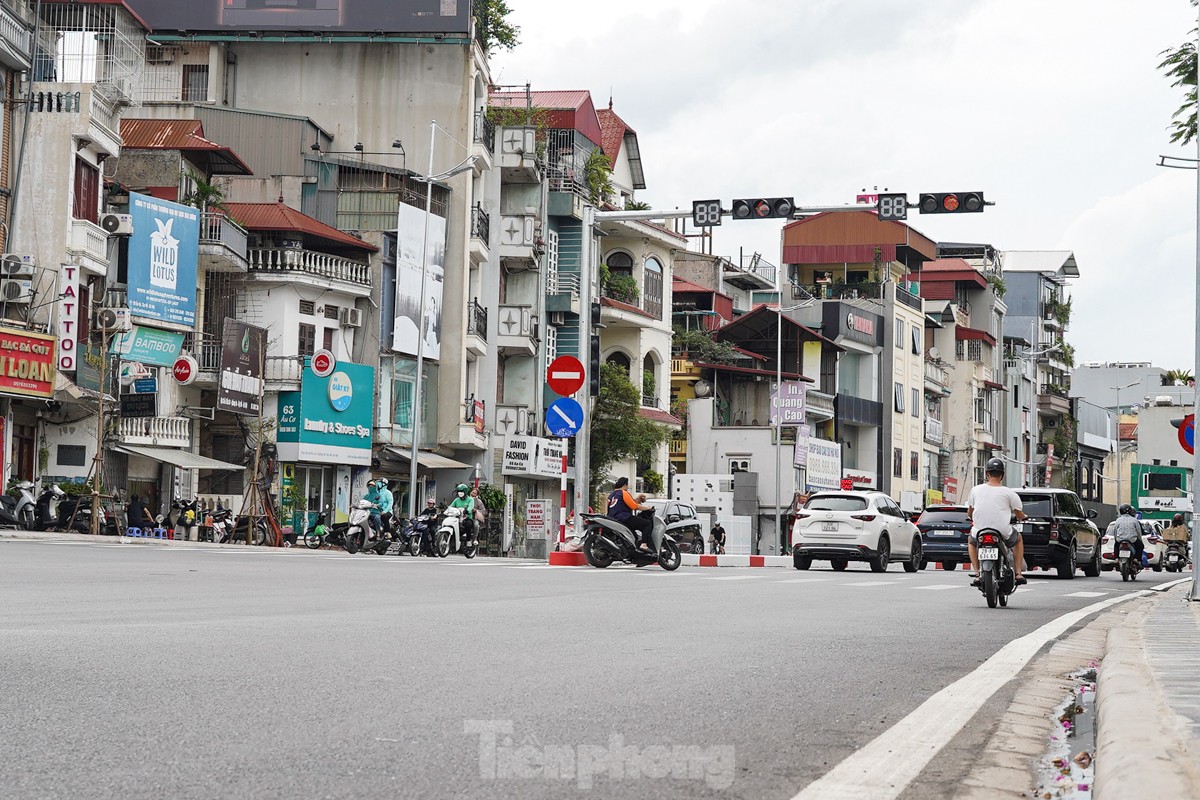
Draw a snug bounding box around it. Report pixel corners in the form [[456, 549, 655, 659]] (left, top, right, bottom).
[[128, 192, 200, 326]]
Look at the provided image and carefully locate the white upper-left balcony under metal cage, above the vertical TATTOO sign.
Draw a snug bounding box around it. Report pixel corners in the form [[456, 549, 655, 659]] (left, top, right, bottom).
[[28, 82, 121, 156]]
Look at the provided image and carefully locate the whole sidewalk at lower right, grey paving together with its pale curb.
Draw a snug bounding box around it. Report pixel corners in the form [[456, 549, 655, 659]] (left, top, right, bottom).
[[1093, 582, 1200, 800]]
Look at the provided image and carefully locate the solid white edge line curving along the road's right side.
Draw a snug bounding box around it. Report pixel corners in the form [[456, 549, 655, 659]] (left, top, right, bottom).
[[793, 590, 1150, 800]]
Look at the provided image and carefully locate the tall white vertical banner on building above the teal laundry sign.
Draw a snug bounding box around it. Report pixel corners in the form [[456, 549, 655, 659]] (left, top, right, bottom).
[[391, 203, 446, 361]]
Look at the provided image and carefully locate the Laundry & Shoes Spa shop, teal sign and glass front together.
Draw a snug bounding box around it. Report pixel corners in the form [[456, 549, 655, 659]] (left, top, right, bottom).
[[276, 359, 374, 524]]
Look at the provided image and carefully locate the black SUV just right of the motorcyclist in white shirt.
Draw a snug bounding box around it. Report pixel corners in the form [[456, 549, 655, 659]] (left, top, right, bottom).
[[1016, 489, 1100, 578]]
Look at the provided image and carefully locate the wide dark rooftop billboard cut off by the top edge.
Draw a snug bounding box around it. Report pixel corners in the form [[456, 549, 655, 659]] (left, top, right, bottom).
[[127, 0, 470, 35]]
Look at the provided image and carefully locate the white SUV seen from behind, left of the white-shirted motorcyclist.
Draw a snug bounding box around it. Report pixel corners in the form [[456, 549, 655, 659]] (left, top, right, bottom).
[[792, 492, 922, 572]]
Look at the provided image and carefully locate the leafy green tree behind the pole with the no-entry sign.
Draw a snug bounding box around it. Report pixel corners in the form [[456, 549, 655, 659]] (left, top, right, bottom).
[[589, 363, 671, 497]]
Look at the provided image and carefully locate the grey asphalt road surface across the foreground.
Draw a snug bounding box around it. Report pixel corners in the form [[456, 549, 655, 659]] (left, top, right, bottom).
[[0, 540, 1172, 800]]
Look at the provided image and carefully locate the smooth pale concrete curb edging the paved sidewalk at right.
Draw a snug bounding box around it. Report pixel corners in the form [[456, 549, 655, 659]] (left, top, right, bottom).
[[1092, 587, 1200, 800]]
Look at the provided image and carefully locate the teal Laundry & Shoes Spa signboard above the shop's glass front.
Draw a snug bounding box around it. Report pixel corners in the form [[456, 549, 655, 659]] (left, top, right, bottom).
[[276, 361, 376, 467]]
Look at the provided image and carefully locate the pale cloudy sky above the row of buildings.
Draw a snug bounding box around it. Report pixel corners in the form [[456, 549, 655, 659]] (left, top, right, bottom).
[[491, 0, 1198, 369]]
